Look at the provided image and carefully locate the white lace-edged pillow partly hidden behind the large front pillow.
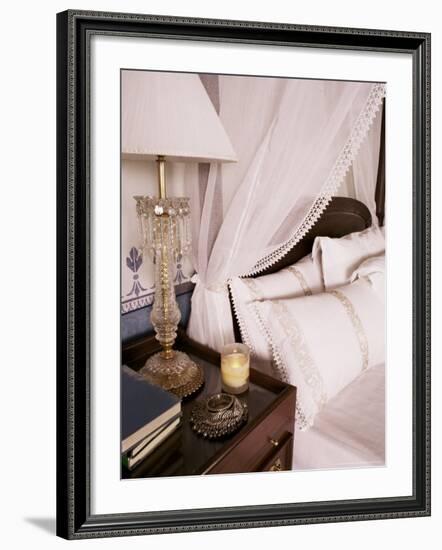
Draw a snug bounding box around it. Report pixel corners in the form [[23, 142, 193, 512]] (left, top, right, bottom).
[[229, 254, 324, 376]]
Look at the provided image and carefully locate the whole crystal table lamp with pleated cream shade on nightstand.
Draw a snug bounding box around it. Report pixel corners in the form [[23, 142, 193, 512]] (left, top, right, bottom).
[[122, 70, 236, 397]]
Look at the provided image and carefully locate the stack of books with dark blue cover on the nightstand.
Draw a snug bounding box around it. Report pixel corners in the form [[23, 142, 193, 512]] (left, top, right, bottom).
[[121, 365, 182, 470]]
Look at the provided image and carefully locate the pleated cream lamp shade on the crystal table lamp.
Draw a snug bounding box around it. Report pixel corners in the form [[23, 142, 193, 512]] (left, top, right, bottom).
[[122, 70, 237, 162]]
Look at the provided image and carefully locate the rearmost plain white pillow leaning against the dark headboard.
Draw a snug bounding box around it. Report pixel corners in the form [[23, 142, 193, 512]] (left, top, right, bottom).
[[312, 226, 385, 290]]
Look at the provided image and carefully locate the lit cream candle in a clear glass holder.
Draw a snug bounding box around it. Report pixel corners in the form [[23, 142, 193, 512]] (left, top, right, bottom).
[[221, 344, 250, 394]]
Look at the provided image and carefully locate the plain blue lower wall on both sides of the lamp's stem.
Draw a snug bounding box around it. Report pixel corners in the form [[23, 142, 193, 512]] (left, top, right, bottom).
[[121, 285, 193, 343]]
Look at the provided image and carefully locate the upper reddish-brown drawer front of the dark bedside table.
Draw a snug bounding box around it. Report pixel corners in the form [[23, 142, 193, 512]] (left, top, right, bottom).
[[204, 394, 295, 474]]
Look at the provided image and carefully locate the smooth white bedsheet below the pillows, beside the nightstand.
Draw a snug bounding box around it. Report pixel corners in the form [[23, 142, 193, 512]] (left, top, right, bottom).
[[293, 364, 385, 470]]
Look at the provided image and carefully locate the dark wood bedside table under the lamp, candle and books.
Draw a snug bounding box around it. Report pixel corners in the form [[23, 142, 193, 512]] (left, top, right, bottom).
[[122, 331, 296, 479]]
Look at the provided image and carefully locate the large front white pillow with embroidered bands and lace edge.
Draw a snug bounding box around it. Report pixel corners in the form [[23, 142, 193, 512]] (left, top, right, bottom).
[[249, 272, 385, 430]]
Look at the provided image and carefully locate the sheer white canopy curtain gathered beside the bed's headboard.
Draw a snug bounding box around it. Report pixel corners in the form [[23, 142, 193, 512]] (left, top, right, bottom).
[[188, 75, 385, 350]]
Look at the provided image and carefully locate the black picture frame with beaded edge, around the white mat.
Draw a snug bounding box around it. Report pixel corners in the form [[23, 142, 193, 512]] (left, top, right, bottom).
[[57, 10, 430, 539]]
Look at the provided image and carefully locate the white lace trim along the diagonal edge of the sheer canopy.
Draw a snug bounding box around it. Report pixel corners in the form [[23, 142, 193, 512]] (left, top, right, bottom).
[[243, 84, 386, 277]]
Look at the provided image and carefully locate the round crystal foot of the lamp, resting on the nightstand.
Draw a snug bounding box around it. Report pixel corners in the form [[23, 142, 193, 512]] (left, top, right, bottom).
[[140, 350, 204, 397]]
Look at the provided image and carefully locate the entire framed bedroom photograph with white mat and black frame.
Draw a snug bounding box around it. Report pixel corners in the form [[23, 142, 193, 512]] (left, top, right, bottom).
[[57, 10, 430, 539]]
